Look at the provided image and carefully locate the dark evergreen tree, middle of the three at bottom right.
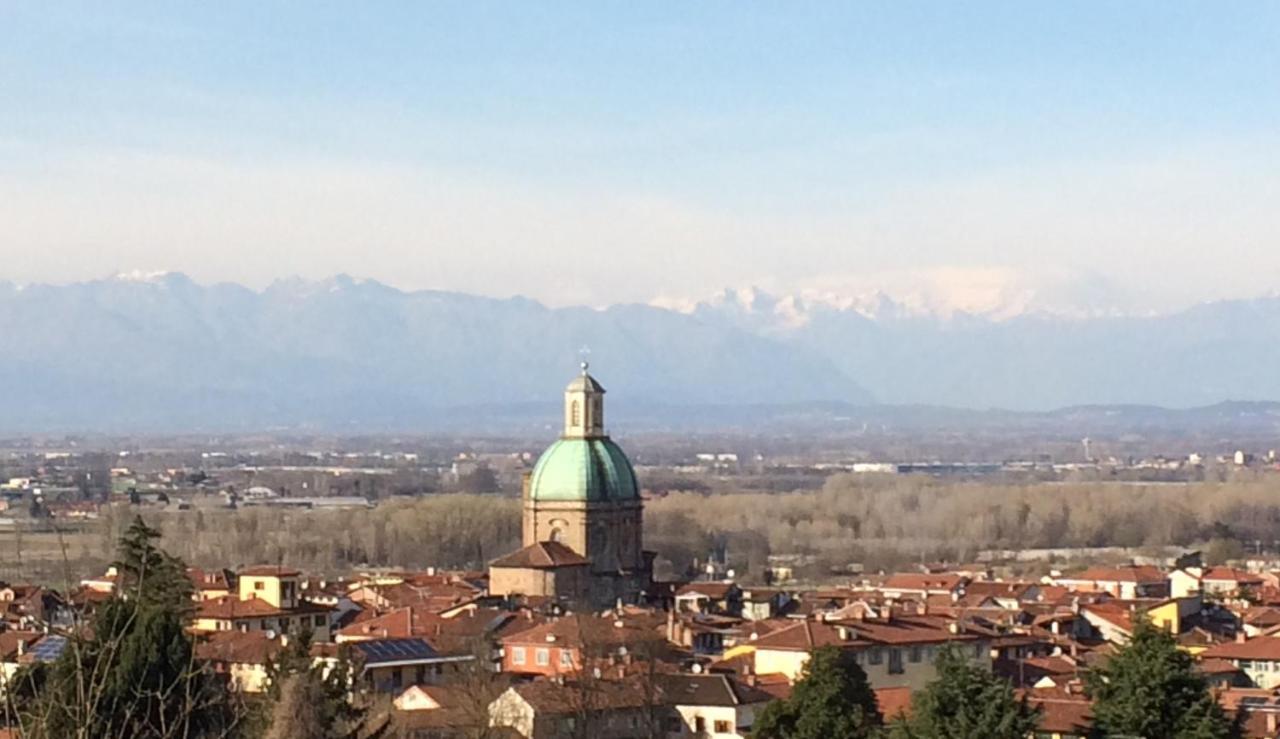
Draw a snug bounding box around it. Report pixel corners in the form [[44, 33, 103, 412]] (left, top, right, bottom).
[[891, 646, 1039, 739]]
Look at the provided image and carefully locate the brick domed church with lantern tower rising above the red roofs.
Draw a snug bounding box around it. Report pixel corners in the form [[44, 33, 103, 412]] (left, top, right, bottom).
[[489, 364, 653, 605]]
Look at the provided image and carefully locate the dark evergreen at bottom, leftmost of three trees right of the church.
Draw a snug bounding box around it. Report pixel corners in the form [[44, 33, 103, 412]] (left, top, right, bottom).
[[753, 647, 884, 739]]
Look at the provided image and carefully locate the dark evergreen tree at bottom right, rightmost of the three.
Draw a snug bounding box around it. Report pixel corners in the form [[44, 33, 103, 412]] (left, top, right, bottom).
[[1085, 621, 1239, 739]]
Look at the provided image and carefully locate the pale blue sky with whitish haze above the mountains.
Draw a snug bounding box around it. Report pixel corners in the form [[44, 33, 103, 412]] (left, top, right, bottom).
[[0, 0, 1280, 310]]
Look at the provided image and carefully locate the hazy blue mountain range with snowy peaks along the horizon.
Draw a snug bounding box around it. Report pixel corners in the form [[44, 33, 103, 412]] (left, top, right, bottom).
[[0, 273, 1280, 430]]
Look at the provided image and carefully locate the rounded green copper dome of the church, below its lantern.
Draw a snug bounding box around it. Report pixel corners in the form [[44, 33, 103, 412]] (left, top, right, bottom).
[[529, 438, 640, 503]]
